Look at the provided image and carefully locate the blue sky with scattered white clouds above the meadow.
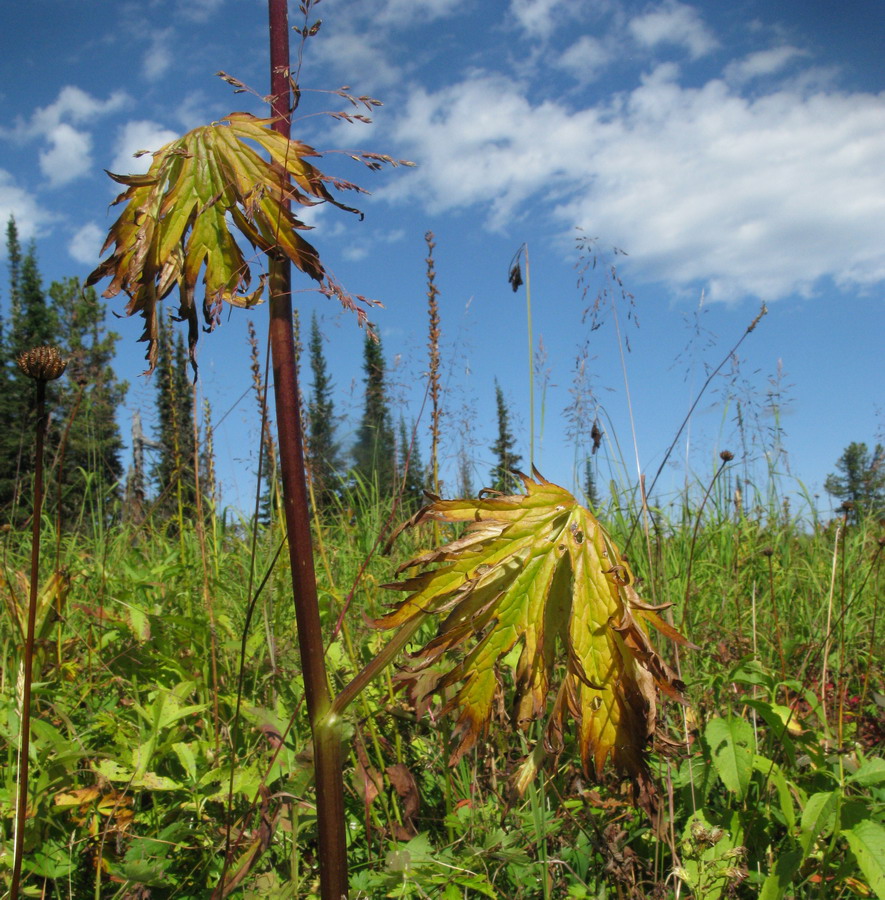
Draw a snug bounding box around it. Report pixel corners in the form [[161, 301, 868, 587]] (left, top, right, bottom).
[[0, 0, 885, 510]]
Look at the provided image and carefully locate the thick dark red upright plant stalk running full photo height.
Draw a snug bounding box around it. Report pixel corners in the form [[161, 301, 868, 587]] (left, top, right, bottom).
[[268, 0, 347, 900]]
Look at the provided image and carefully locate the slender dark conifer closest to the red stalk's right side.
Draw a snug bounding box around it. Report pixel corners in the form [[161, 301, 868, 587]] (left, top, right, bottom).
[[307, 313, 341, 509]]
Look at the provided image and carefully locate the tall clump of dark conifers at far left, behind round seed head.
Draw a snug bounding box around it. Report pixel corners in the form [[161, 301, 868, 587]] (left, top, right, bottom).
[[0, 219, 126, 521]]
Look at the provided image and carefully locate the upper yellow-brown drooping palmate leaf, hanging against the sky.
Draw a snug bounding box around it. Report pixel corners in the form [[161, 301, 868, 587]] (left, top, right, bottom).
[[86, 113, 365, 371]]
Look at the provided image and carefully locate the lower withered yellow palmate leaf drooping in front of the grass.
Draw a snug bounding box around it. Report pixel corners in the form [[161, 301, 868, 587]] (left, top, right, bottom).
[[374, 471, 688, 806]]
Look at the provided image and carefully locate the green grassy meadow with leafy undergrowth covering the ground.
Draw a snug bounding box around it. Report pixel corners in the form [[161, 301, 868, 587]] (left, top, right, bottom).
[[0, 460, 885, 898]]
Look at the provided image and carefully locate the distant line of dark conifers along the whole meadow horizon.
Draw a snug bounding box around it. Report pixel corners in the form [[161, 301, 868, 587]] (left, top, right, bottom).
[[6, 218, 885, 527]]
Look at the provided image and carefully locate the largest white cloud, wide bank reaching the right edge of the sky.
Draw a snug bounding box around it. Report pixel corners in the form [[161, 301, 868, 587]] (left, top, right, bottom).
[[382, 65, 885, 300]]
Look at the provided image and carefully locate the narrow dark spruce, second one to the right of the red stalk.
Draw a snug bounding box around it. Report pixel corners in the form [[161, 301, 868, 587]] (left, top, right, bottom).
[[353, 335, 396, 497]]
